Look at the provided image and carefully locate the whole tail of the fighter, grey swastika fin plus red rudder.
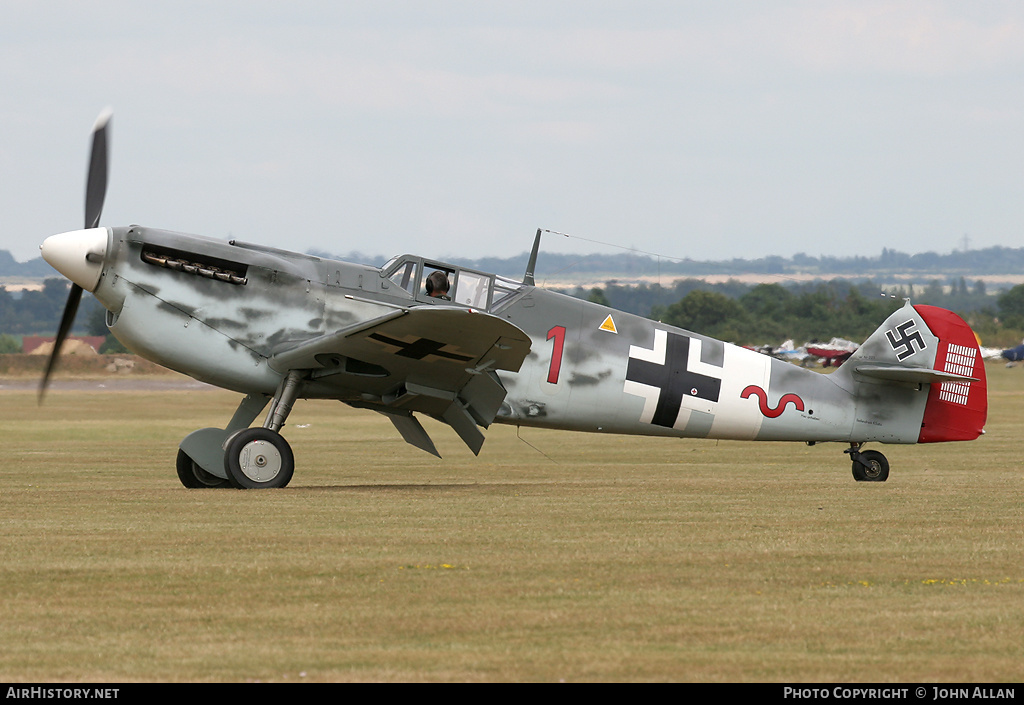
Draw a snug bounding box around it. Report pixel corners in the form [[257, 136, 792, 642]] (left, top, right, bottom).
[[835, 303, 988, 443]]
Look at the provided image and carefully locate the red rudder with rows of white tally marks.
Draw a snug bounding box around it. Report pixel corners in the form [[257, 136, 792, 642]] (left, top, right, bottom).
[[914, 305, 988, 443]]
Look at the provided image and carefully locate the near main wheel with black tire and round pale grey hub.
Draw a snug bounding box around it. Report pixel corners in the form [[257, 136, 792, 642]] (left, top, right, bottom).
[[224, 428, 295, 490]]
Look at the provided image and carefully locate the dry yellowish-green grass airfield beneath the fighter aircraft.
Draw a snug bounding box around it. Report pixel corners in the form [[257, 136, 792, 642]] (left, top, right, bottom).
[[0, 364, 1024, 682]]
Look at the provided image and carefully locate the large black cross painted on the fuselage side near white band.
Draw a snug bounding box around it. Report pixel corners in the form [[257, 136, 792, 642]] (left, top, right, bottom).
[[626, 333, 722, 428]]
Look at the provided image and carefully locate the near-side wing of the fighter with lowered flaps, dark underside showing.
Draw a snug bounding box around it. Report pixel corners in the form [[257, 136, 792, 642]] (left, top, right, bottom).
[[269, 305, 530, 455]]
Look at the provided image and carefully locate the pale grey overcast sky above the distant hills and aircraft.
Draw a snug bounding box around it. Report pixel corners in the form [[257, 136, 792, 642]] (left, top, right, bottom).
[[0, 0, 1024, 261]]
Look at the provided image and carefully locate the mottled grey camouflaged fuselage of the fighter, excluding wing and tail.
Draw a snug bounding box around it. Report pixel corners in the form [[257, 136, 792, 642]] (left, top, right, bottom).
[[39, 225, 962, 443]]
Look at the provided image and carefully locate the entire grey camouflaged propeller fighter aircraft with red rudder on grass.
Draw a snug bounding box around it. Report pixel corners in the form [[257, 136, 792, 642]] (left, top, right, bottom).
[[40, 113, 987, 488]]
